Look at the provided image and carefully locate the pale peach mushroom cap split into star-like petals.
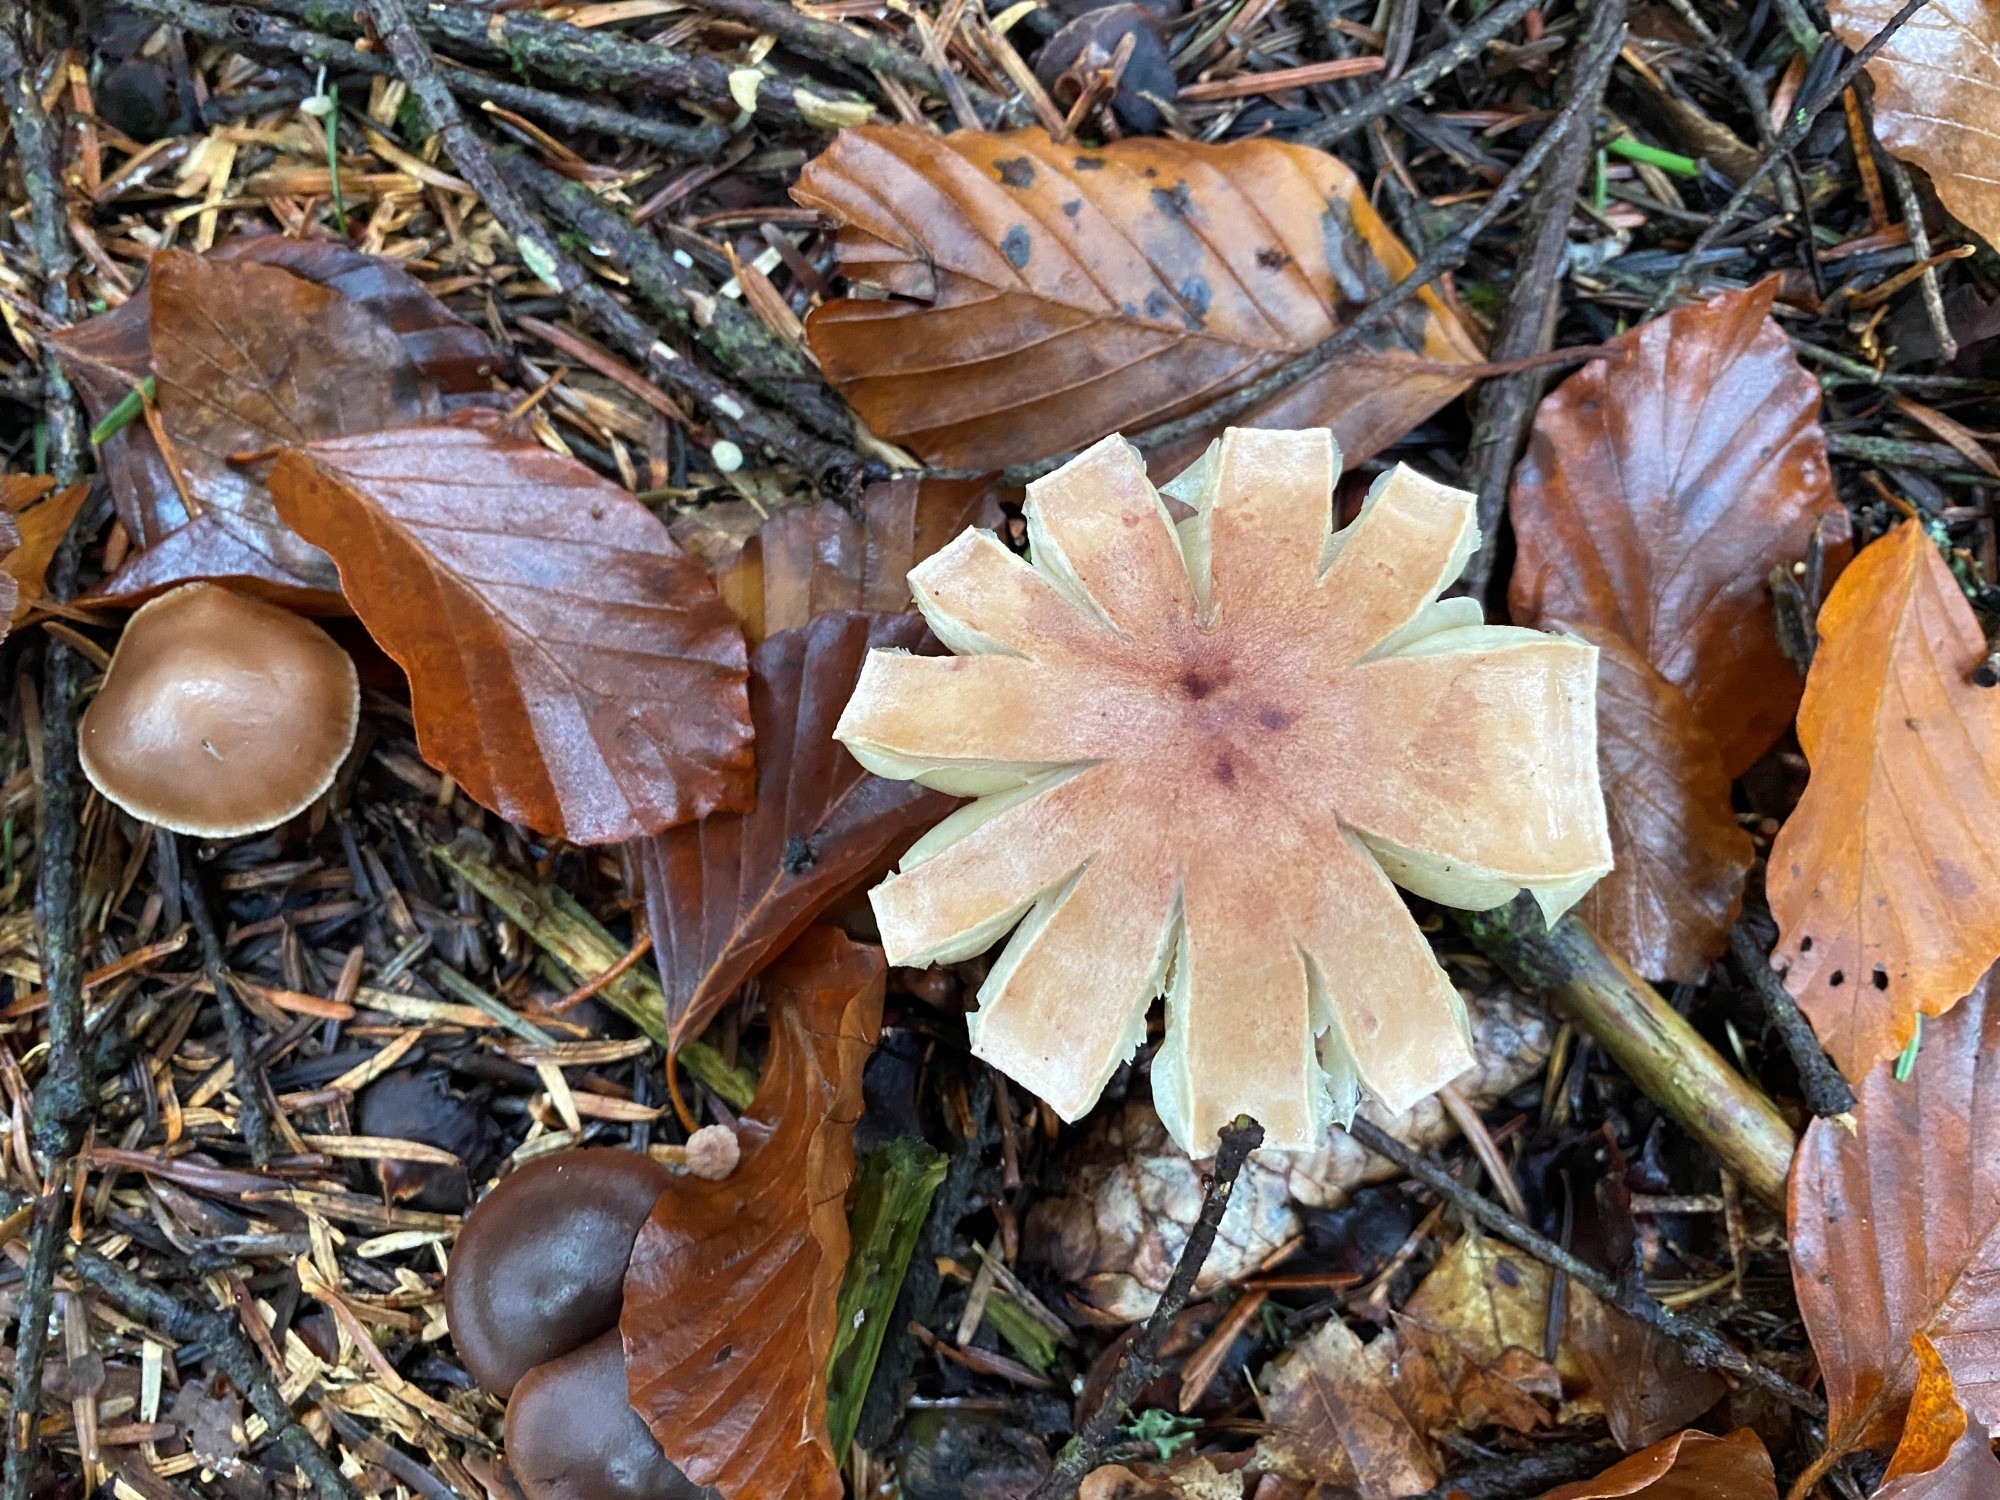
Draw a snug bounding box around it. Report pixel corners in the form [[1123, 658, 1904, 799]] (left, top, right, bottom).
[[834, 428, 1612, 1154]]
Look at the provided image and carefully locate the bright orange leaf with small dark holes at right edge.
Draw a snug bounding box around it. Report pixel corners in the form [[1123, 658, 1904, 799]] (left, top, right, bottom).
[[1764, 520, 2000, 1078]]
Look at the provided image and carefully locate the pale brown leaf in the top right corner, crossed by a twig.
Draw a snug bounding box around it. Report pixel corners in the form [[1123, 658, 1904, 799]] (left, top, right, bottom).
[[1826, 0, 2000, 244]]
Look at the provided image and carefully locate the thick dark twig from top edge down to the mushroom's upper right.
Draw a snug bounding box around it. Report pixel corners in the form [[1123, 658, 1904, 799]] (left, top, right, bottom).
[[1462, 0, 1626, 602]]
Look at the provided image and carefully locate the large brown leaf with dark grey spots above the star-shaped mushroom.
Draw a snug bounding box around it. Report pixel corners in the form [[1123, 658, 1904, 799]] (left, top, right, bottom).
[[792, 126, 1480, 472]]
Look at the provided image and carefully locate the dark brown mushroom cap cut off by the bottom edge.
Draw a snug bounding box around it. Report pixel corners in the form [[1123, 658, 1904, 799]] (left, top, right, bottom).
[[506, 1328, 712, 1500]]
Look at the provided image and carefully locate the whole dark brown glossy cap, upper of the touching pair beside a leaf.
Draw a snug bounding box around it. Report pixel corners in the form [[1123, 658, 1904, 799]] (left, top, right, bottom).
[[444, 1148, 674, 1398]]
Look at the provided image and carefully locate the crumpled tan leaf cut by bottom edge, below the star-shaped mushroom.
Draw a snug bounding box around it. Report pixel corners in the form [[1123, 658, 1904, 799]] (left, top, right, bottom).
[[1258, 1316, 1440, 1500]]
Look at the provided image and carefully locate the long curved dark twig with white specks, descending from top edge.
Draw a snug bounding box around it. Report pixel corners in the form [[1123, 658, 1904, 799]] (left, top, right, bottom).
[[368, 0, 862, 496]]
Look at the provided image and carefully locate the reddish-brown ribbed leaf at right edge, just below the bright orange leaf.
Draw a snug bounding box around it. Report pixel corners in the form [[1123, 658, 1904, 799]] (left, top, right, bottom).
[[1790, 976, 2000, 1454]]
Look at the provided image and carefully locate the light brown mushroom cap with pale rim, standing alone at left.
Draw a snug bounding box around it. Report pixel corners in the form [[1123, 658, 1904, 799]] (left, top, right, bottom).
[[78, 584, 362, 838]]
